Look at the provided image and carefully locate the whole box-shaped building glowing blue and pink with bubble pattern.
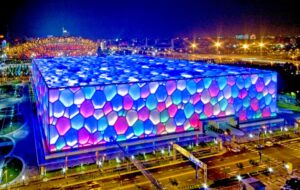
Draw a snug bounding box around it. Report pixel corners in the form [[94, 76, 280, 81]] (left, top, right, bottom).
[[32, 55, 277, 169]]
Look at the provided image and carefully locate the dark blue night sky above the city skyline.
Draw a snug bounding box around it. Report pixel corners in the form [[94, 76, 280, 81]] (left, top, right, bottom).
[[0, 0, 300, 39]]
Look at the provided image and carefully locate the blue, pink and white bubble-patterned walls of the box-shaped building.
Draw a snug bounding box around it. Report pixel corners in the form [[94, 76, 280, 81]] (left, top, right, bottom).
[[33, 57, 277, 152]]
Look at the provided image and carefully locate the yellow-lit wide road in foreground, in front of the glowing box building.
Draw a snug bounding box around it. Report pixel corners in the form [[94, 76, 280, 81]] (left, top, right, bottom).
[[8, 140, 300, 189]]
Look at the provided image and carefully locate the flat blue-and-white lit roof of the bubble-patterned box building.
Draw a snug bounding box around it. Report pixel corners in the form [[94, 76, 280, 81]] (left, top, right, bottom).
[[33, 55, 271, 88]]
